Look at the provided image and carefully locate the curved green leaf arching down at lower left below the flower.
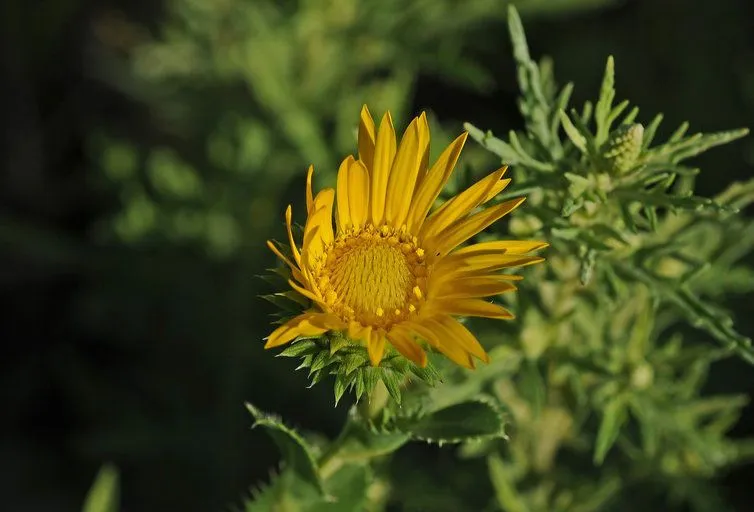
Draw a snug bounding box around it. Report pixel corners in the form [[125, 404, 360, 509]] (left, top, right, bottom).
[[246, 403, 324, 496]]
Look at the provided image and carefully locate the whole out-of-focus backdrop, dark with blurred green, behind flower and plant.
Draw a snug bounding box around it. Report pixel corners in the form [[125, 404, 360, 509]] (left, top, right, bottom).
[[0, 0, 754, 512]]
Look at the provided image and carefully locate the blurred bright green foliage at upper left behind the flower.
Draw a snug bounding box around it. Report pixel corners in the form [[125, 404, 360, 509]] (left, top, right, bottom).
[[91, 0, 610, 258]]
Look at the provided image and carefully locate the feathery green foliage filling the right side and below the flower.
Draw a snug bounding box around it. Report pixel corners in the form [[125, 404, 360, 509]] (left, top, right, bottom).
[[239, 4, 754, 511]]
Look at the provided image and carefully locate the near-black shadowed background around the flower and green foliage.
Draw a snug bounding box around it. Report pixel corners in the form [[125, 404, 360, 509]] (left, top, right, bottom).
[[0, 0, 754, 512]]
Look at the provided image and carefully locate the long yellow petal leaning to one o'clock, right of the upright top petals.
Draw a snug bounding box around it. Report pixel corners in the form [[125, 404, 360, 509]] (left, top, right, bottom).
[[407, 132, 469, 233]]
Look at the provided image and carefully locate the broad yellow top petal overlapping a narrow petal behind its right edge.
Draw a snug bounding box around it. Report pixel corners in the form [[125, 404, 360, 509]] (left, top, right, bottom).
[[385, 117, 428, 228]]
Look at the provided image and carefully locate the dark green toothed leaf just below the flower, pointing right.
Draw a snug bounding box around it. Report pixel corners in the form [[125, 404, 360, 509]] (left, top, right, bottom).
[[396, 399, 505, 444]]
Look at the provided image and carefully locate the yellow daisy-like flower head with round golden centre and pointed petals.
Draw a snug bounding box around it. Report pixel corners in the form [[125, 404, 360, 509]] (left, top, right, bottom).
[[265, 106, 547, 368]]
